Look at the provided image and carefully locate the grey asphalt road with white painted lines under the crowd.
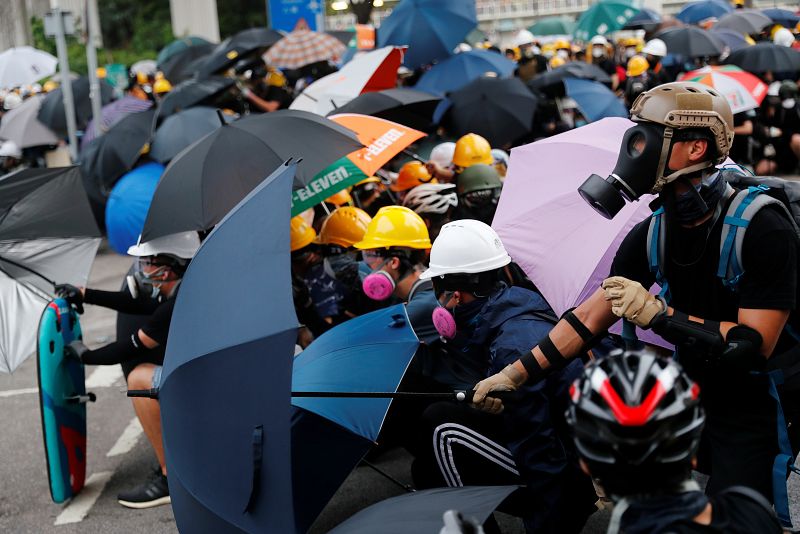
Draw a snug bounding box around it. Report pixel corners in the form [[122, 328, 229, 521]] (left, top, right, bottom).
[[0, 251, 800, 534]]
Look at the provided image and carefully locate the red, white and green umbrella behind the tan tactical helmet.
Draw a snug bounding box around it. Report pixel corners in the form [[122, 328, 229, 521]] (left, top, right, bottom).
[[681, 65, 767, 113]]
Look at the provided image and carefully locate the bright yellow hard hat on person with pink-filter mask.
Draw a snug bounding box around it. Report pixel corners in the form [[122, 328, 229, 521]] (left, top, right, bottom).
[[353, 206, 431, 253]]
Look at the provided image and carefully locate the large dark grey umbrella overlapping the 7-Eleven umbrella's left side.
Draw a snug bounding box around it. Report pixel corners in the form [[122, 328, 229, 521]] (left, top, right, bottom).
[[142, 110, 364, 241]]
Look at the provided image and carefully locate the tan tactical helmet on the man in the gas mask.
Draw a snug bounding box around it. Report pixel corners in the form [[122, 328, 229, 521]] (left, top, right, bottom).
[[631, 82, 733, 193]]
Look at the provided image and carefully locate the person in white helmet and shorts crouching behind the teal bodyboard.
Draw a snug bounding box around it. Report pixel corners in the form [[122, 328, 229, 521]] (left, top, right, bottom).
[[56, 232, 200, 508]]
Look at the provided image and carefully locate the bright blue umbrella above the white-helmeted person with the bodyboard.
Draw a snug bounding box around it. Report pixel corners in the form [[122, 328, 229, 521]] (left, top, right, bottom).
[[106, 161, 164, 254]]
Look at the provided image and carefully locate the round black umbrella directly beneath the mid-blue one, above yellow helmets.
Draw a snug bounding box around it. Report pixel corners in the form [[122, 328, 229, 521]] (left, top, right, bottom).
[[443, 77, 537, 147]]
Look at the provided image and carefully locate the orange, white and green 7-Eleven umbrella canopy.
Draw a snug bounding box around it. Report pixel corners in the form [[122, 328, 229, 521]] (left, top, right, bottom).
[[292, 113, 425, 216]]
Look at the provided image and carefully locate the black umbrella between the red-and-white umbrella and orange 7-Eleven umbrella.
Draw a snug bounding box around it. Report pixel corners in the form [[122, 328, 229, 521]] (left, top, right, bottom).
[[328, 89, 442, 130]]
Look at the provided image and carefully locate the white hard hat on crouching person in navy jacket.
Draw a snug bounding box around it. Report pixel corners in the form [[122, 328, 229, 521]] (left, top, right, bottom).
[[420, 219, 511, 279]]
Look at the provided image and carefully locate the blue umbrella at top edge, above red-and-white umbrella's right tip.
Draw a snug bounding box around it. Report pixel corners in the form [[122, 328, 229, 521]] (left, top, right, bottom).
[[378, 0, 478, 69]]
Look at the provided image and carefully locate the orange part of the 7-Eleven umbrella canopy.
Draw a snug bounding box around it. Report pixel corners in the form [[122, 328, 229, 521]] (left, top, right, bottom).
[[328, 113, 427, 176]]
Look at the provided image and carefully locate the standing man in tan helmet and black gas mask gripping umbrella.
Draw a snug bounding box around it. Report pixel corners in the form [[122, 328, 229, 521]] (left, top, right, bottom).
[[475, 82, 798, 508]]
